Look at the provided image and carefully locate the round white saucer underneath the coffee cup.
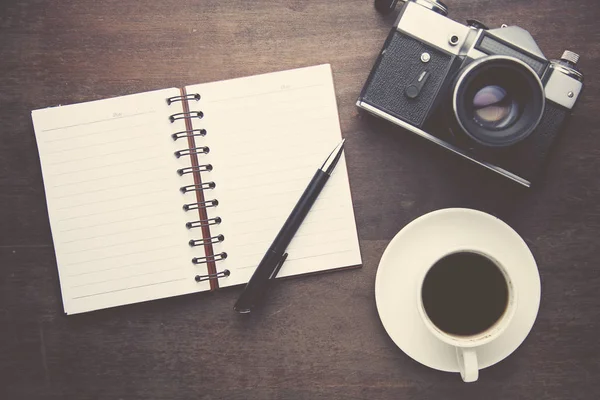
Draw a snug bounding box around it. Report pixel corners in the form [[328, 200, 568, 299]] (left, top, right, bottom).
[[375, 208, 540, 372]]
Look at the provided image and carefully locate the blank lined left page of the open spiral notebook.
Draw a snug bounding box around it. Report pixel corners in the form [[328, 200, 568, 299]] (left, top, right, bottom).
[[32, 89, 209, 314]]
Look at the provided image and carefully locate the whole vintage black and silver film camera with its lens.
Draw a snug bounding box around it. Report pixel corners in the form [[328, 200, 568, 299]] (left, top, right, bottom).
[[357, 0, 583, 186]]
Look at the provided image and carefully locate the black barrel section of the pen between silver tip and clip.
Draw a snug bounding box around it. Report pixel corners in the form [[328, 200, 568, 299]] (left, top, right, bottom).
[[269, 169, 329, 252]]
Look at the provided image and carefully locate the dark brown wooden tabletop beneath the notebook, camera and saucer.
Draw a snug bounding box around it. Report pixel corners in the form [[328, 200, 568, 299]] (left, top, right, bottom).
[[0, 0, 600, 400]]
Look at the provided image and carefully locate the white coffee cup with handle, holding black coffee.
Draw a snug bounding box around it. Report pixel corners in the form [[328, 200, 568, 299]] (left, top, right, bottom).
[[417, 249, 517, 382]]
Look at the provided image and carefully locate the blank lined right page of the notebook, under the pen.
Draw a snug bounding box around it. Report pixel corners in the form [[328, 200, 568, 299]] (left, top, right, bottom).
[[186, 65, 361, 287]]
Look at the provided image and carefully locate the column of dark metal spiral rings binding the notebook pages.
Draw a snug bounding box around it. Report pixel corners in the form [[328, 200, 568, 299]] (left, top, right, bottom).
[[167, 93, 230, 287]]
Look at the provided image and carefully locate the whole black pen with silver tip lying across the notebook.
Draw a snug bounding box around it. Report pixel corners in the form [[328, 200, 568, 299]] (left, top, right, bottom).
[[233, 139, 346, 314]]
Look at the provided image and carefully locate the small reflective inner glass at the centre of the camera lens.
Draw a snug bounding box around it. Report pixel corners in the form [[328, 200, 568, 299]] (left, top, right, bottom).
[[473, 85, 519, 129]]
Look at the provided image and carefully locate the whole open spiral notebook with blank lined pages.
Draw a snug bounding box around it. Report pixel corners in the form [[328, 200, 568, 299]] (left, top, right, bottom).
[[32, 65, 361, 314]]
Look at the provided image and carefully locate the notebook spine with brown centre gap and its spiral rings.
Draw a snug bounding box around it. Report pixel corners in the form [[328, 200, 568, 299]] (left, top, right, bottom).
[[166, 89, 230, 290]]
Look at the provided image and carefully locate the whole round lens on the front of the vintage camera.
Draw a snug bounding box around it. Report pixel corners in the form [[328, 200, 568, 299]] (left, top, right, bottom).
[[453, 56, 545, 147]]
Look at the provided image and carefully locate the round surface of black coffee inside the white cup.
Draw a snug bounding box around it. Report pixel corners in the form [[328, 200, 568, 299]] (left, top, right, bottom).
[[422, 252, 508, 336]]
